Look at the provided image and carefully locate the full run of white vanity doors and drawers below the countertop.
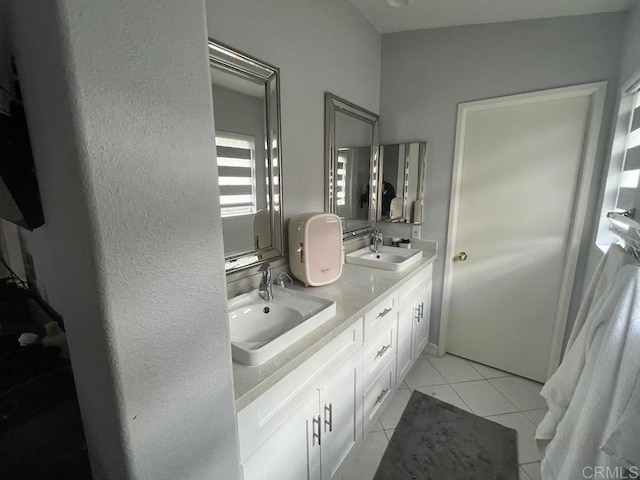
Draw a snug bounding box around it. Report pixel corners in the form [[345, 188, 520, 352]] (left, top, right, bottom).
[[238, 258, 432, 480]]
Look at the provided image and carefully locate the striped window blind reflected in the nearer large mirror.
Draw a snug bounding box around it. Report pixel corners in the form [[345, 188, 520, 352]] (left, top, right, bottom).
[[216, 132, 256, 217]]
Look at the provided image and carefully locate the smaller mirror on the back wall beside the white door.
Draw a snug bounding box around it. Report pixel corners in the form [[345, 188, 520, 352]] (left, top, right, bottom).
[[377, 142, 427, 224]]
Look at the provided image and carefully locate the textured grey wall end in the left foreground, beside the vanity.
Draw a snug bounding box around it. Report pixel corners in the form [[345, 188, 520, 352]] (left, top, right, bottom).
[[13, 0, 238, 480]]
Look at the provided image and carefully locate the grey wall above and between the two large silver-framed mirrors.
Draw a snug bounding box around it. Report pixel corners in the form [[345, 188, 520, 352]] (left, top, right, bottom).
[[206, 0, 380, 219]]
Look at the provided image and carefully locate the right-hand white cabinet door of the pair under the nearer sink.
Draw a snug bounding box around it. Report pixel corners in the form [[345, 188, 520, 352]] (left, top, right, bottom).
[[320, 353, 362, 480]]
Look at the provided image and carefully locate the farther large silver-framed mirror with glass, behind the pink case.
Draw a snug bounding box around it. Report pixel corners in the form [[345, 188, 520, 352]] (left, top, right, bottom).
[[325, 92, 379, 237]]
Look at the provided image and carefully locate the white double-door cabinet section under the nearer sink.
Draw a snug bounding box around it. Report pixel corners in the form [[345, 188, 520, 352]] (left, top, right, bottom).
[[238, 320, 363, 480]]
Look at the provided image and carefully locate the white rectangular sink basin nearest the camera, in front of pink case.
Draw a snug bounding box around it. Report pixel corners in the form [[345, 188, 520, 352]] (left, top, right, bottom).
[[229, 286, 336, 365]]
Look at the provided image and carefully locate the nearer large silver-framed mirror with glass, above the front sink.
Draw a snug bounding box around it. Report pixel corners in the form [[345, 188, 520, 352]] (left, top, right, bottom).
[[209, 39, 284, 273]]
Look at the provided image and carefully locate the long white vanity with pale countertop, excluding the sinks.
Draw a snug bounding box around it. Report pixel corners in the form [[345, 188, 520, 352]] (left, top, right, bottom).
[[233, 246, 436, 480]]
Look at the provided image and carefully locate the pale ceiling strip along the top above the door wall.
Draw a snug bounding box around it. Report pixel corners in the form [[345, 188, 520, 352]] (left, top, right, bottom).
[[349, 0, 636, 33]]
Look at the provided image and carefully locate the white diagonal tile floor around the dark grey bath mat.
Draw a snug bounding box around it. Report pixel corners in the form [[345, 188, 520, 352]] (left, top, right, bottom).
[[343, 354, 546, 480]]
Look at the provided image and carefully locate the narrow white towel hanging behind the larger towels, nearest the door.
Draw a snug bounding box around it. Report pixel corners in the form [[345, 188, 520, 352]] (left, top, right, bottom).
[[565, 243, 636, 351]]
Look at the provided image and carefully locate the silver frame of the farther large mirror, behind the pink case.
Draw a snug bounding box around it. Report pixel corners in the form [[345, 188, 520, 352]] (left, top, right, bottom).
[[324, 92, 380, 239]]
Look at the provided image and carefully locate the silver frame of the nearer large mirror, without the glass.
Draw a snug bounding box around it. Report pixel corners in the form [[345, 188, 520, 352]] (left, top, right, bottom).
[[208, 38, 285, 275]]
